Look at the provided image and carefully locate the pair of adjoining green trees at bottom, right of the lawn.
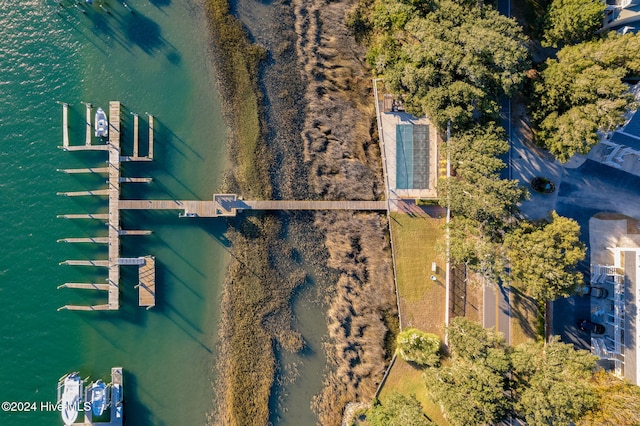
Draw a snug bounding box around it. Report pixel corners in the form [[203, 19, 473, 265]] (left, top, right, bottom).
[[424, 318, 598, 426]]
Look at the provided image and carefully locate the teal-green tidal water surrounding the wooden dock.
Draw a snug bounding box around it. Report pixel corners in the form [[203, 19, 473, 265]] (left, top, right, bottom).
[[0, 0, 227, 426]]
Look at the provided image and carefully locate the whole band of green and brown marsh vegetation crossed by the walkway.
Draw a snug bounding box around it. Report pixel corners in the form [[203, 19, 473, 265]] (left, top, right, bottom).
[[206, 0, 398, 426]]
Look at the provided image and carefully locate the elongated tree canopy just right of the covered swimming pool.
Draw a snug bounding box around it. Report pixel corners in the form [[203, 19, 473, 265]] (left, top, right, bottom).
[[438, 123, 528, 277]]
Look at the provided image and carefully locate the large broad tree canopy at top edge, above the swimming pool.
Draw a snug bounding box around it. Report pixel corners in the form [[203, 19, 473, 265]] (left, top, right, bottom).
[[358, 0, 529, 129]]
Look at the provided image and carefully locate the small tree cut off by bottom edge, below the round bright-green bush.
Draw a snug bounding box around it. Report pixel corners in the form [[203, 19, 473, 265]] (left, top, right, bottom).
[[366, 392, 433, 426]]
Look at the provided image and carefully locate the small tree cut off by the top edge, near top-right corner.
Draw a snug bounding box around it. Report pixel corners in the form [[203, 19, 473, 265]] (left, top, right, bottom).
[[542, 0, 606, 47]]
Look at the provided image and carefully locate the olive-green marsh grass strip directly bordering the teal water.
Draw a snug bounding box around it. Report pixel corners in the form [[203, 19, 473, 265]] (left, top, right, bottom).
[[207, 0, 304, 426]]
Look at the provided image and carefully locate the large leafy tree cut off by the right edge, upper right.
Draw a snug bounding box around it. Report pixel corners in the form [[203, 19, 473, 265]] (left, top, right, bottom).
[[532, 33, 640, 161]]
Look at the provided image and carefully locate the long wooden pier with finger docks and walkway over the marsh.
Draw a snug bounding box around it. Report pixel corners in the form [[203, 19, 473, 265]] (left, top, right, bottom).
[[58, 101, 388, 311]]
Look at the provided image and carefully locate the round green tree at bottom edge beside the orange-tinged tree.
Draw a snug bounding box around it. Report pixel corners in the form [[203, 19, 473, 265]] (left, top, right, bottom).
[[511, 336, 598, 426]]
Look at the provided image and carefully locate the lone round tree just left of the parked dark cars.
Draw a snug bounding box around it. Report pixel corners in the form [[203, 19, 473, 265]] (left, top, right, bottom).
[[504, 212, 586, 301]]
